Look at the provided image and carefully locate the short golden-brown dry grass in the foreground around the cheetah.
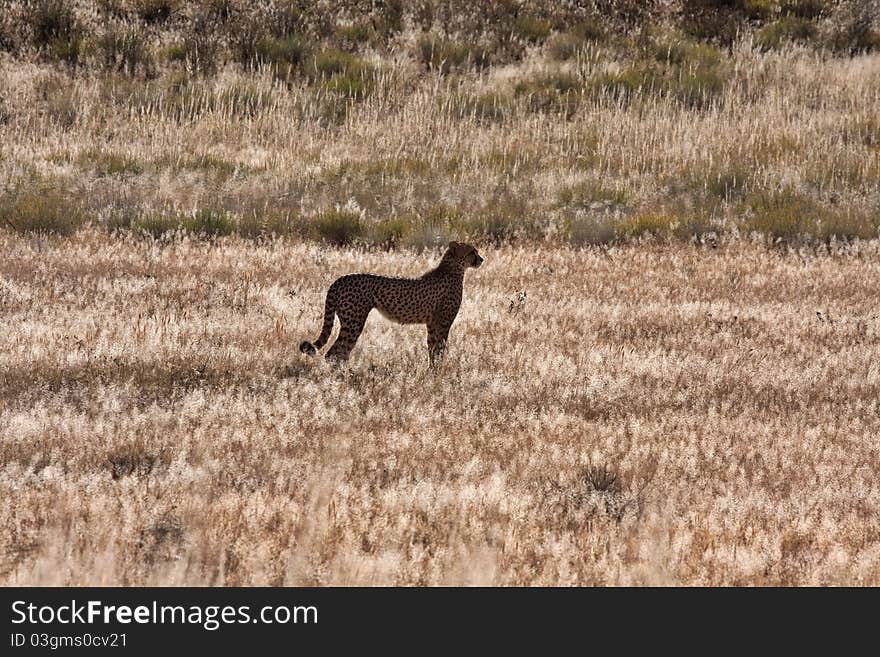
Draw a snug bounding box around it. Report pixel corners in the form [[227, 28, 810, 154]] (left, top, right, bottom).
[[0, 230, 880, 585]]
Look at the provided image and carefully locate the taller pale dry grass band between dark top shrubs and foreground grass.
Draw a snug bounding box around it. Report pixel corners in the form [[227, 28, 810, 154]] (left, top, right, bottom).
[[0, 35, 880, 246]]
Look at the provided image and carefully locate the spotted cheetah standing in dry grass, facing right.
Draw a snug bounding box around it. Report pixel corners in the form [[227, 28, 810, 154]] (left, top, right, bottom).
[[299, 242, 483, 367]]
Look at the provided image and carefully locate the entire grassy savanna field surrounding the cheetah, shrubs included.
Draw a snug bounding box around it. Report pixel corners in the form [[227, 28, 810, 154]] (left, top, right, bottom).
[[0, 0, 880, 585]]
